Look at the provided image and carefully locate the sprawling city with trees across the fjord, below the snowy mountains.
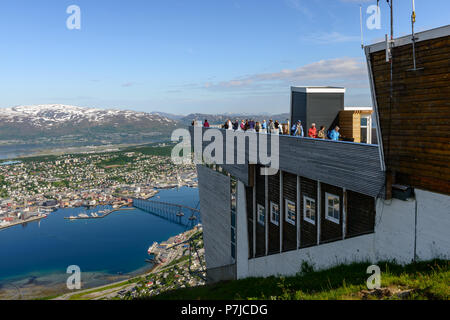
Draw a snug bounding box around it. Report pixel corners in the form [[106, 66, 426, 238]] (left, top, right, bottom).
[[0, 144, 197, 229]]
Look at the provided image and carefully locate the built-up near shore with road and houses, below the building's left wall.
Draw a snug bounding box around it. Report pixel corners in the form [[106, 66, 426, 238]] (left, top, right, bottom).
[[53, 224, 206, 300]]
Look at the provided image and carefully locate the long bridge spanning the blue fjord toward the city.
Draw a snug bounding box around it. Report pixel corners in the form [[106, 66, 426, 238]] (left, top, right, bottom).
[[133, 198, 201, 227]]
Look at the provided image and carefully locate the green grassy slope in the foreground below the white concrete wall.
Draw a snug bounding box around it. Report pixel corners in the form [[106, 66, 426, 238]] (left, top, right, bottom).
[[146, 260, 450, 300]]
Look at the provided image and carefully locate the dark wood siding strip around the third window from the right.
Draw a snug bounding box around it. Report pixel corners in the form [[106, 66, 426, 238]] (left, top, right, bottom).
[[282, 172, 297, 251]]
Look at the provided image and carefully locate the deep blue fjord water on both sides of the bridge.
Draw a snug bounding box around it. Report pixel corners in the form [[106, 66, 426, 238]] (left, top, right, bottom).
[[0, 187, 198, 291]]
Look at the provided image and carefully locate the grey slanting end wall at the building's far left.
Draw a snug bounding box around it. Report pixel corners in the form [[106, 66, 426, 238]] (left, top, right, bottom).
[[197, 165, 234, 269]]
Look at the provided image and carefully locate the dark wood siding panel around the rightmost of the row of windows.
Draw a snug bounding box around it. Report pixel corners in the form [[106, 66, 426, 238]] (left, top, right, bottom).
[[320, 183, 344, 243]]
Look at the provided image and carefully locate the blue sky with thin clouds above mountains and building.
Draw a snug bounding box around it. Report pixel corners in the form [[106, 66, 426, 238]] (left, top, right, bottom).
[[0, 0, 450, 114]]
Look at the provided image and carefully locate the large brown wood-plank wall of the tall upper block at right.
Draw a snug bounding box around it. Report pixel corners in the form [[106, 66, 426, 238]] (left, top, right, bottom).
[[370, 35, 450, 194]]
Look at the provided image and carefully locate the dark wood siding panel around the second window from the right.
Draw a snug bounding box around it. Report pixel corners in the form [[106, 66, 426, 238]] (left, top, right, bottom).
[[300, 177, 318, 248]]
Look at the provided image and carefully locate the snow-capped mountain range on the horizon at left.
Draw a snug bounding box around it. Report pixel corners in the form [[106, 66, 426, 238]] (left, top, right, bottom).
[[0, 104, 178, 143]]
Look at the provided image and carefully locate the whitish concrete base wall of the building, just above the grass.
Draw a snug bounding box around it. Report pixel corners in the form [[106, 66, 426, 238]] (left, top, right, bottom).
[[237, 190, 450, 279]]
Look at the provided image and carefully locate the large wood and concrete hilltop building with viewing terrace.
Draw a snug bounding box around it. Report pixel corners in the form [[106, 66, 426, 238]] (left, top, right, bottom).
[[190, 26, 450, 282]]
